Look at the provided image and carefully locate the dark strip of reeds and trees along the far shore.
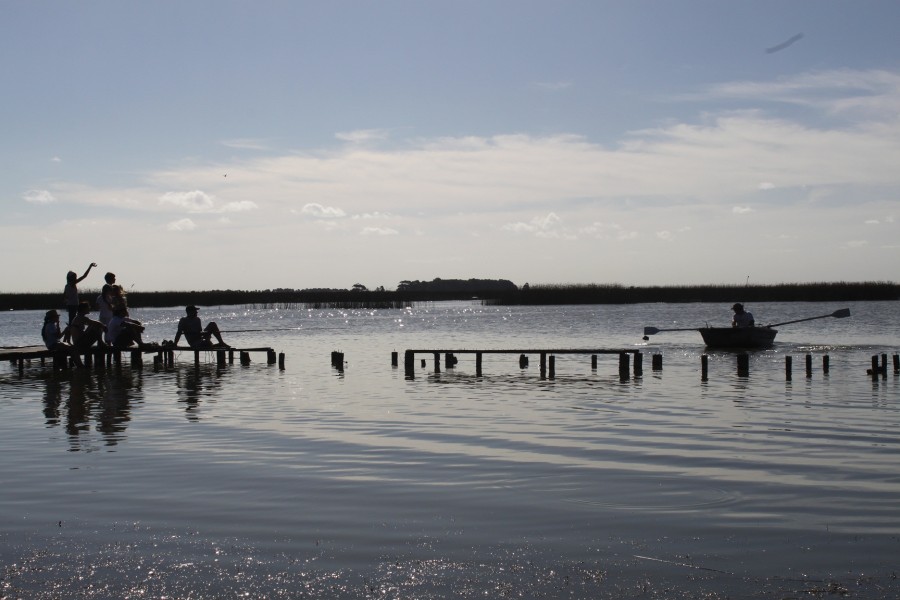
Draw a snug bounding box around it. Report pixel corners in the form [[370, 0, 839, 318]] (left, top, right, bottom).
[[0, 279, 900, 311]]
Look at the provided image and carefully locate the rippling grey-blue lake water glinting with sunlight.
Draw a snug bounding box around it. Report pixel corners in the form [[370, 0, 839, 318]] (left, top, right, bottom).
[[0, 302, 900, 599]]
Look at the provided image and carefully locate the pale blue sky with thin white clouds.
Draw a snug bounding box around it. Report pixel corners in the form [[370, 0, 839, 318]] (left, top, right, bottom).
[[0, 0, 900, 293]]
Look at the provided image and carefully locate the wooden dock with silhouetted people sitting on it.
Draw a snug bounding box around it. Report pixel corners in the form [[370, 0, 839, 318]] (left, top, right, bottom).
[[0, 345, 284, 375]]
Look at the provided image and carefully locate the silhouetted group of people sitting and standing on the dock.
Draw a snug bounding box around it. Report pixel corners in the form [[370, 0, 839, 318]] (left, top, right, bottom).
[[41, 263, 229, 364]]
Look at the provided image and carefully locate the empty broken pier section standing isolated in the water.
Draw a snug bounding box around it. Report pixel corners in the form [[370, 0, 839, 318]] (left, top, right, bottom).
[[403, 348, 648, 379]]
